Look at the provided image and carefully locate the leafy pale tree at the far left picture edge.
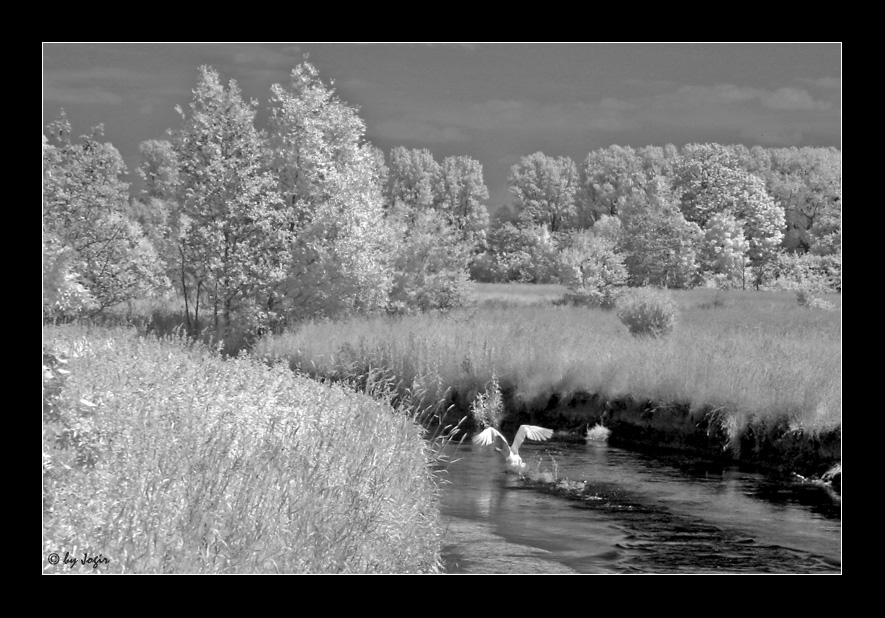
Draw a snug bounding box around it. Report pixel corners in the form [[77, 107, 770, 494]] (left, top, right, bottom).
[[43, 115, 168, 313]]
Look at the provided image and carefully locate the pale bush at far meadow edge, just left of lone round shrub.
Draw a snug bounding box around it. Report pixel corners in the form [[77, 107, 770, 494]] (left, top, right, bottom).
[[559, 229, 627, 309]]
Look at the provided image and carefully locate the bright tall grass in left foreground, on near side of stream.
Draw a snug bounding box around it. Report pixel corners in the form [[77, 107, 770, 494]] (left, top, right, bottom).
[[43, 326, 440, 573]]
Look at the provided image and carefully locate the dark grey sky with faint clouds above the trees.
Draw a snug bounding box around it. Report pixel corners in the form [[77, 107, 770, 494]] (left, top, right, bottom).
[[43, 43, 842, 211]]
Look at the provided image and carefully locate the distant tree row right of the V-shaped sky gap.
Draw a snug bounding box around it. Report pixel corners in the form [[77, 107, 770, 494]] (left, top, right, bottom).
[[473, 144, 842, 300]]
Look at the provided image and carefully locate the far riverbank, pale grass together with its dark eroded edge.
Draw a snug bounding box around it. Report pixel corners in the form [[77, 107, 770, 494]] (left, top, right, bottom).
[[254, 286, 842, 485]]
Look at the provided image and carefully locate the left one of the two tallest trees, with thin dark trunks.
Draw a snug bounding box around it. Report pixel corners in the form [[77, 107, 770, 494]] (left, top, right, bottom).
[[174, 66, 290, 337]]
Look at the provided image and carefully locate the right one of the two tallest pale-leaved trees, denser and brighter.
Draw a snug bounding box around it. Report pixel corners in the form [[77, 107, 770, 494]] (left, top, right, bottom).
[[270, 62, 393, 319]]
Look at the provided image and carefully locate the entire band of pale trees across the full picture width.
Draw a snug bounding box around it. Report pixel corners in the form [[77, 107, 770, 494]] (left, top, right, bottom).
[[43, 62, 841, 337]]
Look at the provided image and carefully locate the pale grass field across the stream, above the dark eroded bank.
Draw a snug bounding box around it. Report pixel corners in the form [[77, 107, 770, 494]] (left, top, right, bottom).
[[254, 284, 842, 433]]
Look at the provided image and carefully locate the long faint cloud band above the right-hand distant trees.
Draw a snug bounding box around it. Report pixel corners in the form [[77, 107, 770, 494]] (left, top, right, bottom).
[[370, 82, 839, 146]]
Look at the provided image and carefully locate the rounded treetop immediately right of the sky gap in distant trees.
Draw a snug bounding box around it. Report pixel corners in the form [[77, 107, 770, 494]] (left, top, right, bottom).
[[508, 152, 578, 233]]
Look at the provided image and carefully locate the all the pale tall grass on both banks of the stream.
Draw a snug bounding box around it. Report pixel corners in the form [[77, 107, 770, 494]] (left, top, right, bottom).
[[43, 284, 842, 573]]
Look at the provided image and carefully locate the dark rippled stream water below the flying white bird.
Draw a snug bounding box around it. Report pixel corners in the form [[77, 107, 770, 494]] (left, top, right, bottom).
[[442, 443, 842, 573]]
